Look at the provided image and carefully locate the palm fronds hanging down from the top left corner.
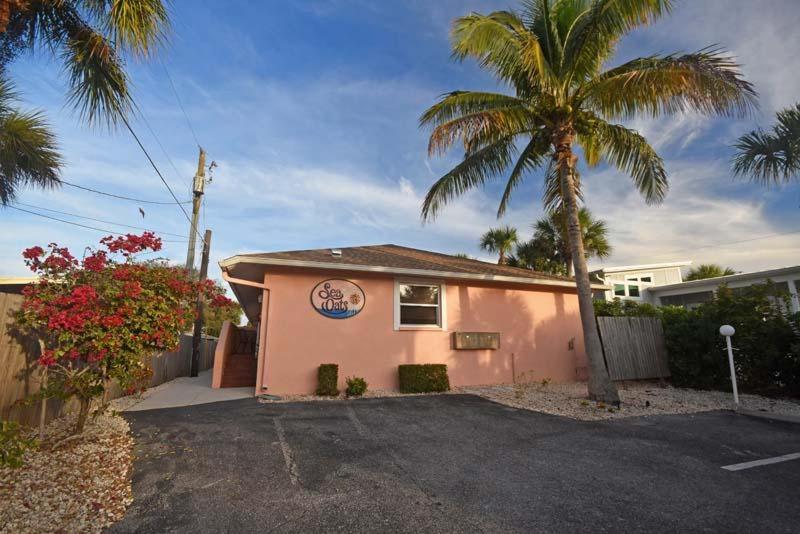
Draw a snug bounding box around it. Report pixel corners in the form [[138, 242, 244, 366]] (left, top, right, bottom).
[[0, 0, 169, 125]]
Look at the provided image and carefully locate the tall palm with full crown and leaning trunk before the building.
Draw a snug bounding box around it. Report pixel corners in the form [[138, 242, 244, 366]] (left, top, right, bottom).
[[420, 0, 756, 403]]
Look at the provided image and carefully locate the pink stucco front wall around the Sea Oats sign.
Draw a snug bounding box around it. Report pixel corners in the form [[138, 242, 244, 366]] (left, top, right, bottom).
[[256, 271, 586, 394]]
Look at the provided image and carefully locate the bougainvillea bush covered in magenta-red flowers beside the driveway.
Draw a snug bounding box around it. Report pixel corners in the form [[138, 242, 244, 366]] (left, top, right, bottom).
[[16, 232, 233, 432]]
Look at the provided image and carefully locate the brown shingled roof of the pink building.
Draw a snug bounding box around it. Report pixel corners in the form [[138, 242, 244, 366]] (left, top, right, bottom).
[[220, 244, 574, 284]]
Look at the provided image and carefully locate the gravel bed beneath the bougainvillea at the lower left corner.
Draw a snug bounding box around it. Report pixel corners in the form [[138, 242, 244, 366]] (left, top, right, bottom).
[[0, 415, 133, 534]]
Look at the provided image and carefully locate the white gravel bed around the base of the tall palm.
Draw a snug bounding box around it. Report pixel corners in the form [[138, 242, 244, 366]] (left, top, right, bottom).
[[458, 383, 800, 421]]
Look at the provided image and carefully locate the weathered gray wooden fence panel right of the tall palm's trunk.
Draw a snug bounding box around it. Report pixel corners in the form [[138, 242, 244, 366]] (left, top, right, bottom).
[[597, 317, 670, 380]]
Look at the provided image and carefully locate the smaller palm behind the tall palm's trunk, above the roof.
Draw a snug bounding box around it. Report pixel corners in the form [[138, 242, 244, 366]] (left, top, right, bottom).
[[533, 208, 611, 276]]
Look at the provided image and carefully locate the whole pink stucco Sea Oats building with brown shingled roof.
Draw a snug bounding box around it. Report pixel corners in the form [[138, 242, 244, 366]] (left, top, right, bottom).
[[213, 245, 604, 395]]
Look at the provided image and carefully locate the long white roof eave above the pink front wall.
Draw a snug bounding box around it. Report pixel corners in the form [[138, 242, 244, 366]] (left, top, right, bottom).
[[219, 256, 612, 290]]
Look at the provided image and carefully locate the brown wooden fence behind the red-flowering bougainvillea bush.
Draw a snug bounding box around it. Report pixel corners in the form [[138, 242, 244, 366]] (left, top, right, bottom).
[[0, 293, 217, 426]]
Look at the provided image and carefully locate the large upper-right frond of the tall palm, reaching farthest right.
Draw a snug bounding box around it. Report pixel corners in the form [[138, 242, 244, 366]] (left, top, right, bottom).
[[579, 49, 757, 118]]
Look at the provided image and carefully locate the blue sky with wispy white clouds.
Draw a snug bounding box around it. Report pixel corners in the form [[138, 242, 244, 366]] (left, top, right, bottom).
[[0, 0, 800, 288]]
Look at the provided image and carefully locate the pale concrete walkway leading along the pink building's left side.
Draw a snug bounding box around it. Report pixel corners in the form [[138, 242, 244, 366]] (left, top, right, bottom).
[[112, 370, 254, 412]]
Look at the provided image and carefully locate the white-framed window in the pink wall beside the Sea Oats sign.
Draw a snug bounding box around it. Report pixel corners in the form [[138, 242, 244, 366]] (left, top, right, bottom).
[[394, 279, 447, 330]]
